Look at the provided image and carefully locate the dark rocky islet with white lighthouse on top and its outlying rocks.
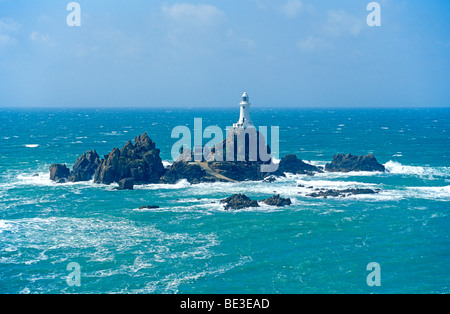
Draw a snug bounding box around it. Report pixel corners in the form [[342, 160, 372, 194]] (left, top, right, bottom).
[[49, 93, 386, 209]]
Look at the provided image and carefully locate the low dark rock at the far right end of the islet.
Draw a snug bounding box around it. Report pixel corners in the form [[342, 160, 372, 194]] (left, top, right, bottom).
[[325, 154, 386, 172]]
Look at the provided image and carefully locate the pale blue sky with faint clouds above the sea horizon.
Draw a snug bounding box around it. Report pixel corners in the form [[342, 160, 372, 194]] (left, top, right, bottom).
[[0, 0, 450, 108]]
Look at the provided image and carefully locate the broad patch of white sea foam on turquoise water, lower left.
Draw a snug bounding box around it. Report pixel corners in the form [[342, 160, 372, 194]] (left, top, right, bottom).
[[0, 217, 220, 265]]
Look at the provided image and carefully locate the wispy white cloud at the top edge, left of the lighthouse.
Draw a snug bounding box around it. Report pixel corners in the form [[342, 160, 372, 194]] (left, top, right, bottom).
[[162, 3, 225, 26]]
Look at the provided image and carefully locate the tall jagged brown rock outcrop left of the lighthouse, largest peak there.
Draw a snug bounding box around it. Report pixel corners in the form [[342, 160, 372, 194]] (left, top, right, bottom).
[[94, 133, 165, 184]]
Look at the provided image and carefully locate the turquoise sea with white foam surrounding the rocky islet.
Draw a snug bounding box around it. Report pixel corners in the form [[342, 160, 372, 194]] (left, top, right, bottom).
[[0, 108, 450, 293]]
